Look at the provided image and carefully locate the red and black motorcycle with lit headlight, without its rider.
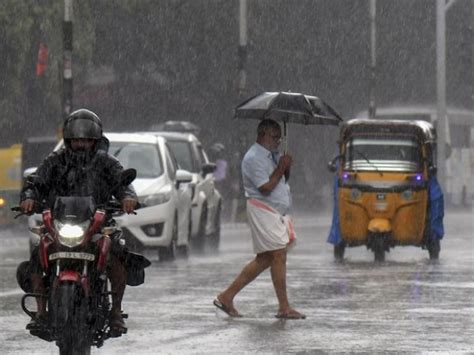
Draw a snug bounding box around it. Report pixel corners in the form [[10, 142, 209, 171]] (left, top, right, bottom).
[[13, 171, 150, 354]]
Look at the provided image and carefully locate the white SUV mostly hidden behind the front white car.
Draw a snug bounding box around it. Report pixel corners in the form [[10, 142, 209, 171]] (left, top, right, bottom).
[[146, 132, 222, 251]]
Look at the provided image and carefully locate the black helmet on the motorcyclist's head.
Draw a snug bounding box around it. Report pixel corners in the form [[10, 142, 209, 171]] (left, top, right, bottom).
[[63, 109, 102, 141]]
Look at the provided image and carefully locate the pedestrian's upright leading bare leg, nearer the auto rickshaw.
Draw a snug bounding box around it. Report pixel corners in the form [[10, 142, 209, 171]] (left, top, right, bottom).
[[270, 248, 305, 319]]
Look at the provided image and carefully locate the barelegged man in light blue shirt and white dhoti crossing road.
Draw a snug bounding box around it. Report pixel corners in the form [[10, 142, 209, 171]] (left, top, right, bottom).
[[214, 119, 305, 319]]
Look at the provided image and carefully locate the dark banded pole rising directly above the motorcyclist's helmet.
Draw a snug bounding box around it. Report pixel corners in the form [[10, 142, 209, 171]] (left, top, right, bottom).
[[63, 0, 73, 117]]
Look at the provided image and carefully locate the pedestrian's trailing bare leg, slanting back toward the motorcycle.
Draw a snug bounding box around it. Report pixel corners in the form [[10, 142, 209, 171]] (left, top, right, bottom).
[[217, 252, 271, 315]]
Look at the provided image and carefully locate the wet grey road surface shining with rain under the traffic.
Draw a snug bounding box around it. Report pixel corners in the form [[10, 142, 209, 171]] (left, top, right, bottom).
[[0, 212, 474, 354]]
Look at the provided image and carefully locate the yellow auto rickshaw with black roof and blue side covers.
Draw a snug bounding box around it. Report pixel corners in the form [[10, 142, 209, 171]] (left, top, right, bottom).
[[328, 119, 444, 261]]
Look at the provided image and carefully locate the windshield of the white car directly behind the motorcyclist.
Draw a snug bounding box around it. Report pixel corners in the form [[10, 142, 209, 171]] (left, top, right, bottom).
[[109, 142, 163, 178]]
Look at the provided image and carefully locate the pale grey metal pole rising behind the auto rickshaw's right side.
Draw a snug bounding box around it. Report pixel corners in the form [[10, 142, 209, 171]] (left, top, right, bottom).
[[436, 0, 447, 191]]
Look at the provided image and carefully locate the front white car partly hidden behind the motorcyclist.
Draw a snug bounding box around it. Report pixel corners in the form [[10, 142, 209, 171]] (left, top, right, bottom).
[[29, 133, 192, 261]]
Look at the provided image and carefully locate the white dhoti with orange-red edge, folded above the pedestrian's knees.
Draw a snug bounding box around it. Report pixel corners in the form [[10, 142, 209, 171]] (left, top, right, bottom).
[[247, 199, 296, 254]]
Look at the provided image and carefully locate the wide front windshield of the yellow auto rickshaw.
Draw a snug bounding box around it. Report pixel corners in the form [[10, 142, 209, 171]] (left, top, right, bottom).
[[345, 137, 421, 172]]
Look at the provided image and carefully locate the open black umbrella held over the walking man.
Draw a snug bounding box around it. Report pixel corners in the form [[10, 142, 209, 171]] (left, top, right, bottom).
[[234, 92, 342, 151]]
